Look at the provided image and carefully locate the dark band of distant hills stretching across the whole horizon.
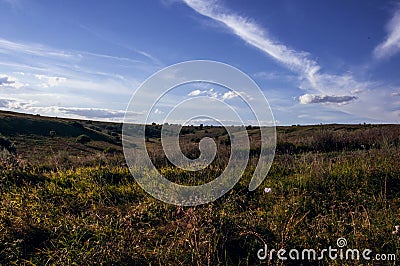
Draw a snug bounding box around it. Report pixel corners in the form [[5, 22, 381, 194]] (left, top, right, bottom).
[[0, 111, 400, 157]]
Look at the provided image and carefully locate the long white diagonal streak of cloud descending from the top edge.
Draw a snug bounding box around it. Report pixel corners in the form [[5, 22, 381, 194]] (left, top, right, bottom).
[[183, 0, 366, 95]]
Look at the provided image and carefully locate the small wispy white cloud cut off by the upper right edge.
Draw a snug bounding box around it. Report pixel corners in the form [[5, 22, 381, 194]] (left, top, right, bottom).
[[374, 4, 400, 59]]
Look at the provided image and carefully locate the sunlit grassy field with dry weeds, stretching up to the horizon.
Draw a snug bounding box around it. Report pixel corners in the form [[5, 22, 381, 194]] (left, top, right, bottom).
[[0, 109, 400, 265]]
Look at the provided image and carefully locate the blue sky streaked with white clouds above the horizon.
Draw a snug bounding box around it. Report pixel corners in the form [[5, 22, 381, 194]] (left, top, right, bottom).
[[0, 0, 400, 125]]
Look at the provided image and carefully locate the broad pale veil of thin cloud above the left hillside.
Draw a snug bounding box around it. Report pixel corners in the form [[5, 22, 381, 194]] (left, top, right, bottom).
[[0, 38, 159, 121]]
